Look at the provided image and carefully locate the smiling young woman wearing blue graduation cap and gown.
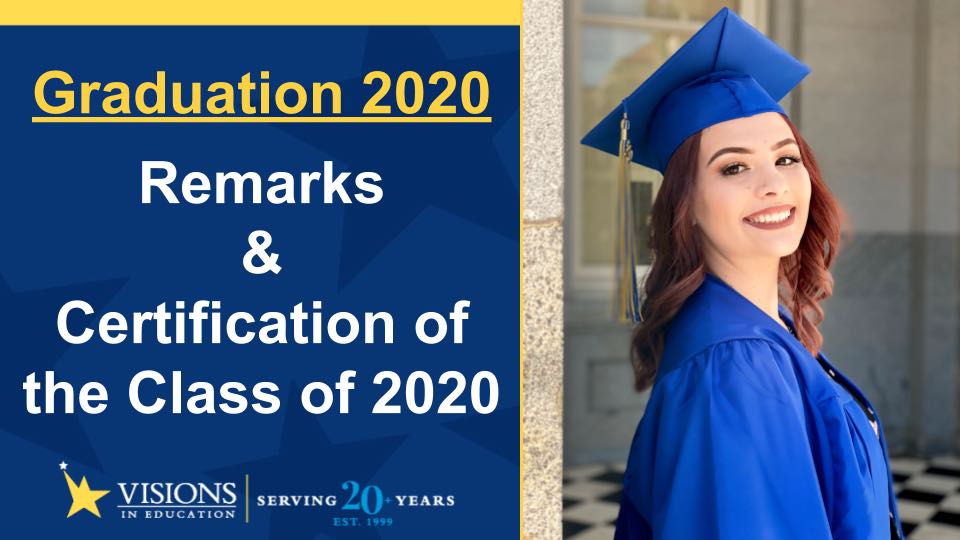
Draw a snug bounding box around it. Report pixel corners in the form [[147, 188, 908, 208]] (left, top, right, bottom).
[[584, 5, 903, 540]]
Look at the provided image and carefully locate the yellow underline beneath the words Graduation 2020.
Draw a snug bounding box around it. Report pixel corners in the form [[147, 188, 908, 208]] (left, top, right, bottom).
[[30, 116, 493, 124]]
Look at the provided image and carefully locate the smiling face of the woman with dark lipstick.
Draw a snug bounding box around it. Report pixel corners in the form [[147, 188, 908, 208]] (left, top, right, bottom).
[[693, 112, 810, 266]]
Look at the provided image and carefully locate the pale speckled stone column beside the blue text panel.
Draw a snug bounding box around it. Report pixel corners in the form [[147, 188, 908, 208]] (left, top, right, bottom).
[[520, 0, 563, 539]]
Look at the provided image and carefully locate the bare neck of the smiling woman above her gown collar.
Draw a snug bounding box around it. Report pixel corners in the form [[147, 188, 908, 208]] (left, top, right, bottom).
[[707, 255, 787, 328]]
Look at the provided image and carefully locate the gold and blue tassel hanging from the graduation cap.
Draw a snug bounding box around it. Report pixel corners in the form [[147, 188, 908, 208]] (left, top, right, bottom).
[[614, 109, 642, 323]]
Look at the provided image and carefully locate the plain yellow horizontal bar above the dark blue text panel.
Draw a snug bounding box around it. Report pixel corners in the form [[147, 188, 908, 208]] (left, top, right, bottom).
[[0, 0, 522, 26]]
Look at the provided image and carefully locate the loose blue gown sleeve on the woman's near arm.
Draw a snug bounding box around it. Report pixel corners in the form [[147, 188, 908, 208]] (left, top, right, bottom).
[[615, 339, 831, 540]]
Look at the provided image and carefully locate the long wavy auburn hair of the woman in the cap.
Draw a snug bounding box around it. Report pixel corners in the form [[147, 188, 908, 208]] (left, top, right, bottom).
[[630, 114, 849, 392]]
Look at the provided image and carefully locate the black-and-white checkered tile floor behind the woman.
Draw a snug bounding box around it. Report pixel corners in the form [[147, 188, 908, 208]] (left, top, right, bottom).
[[563, 456, 960, 540]]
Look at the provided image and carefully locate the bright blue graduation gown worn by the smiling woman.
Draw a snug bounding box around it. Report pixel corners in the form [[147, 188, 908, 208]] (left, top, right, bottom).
[[614, 273, 903, 540]]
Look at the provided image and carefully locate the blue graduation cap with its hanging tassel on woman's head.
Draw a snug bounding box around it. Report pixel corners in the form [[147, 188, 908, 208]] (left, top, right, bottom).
[[580, 7, 810, 322]]
